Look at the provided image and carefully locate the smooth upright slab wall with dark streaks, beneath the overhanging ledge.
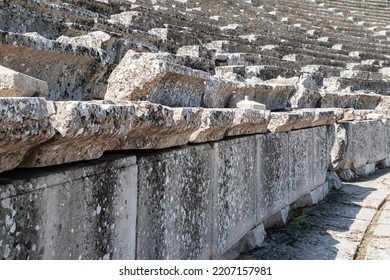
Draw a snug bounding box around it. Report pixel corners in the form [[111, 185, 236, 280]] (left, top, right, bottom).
[[0, 126, 330, 259]]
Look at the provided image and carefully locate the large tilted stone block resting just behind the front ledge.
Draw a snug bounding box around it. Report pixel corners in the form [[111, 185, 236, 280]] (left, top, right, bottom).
[[105, 51, 209, 107]]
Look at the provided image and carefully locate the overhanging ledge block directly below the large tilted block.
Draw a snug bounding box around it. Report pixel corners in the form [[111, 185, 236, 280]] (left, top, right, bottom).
[[117, 102, 203, 150]]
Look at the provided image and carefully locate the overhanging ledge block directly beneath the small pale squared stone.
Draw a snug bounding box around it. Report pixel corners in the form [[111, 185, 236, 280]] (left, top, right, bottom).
[[225, 109, 271, 136]]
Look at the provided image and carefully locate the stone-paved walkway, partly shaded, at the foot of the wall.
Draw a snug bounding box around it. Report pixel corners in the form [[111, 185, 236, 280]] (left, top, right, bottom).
[[239, 169, 390, 260]]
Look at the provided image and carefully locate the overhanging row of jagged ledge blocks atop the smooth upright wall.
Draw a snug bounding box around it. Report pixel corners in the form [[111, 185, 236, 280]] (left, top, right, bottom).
[[0, 94, 380, 172]]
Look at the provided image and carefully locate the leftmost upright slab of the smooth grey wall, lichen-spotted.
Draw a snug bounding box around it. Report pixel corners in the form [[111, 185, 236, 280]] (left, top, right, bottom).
[[0, 155, 137, 260]]
